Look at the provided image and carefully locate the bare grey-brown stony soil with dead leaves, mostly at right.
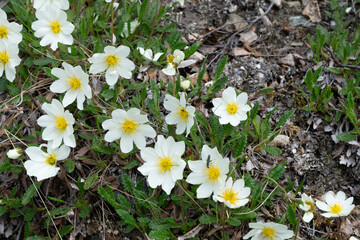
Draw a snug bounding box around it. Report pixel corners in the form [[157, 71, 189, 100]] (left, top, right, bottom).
[[0, 0, 360, 239]]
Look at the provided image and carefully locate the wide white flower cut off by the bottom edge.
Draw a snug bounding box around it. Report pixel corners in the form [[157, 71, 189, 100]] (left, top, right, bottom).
[[243, 222, 294, 240]]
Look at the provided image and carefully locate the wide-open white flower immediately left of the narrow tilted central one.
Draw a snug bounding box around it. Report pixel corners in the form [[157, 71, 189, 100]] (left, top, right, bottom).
[[102, 108, 156, 153]]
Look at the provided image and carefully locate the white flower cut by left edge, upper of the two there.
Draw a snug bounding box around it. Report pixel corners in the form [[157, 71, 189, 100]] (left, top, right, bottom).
[[0, 8, 22, 44]]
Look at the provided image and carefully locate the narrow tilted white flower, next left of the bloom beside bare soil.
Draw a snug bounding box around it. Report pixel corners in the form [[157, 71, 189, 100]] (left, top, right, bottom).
[[164, 93, 195, 136]]
